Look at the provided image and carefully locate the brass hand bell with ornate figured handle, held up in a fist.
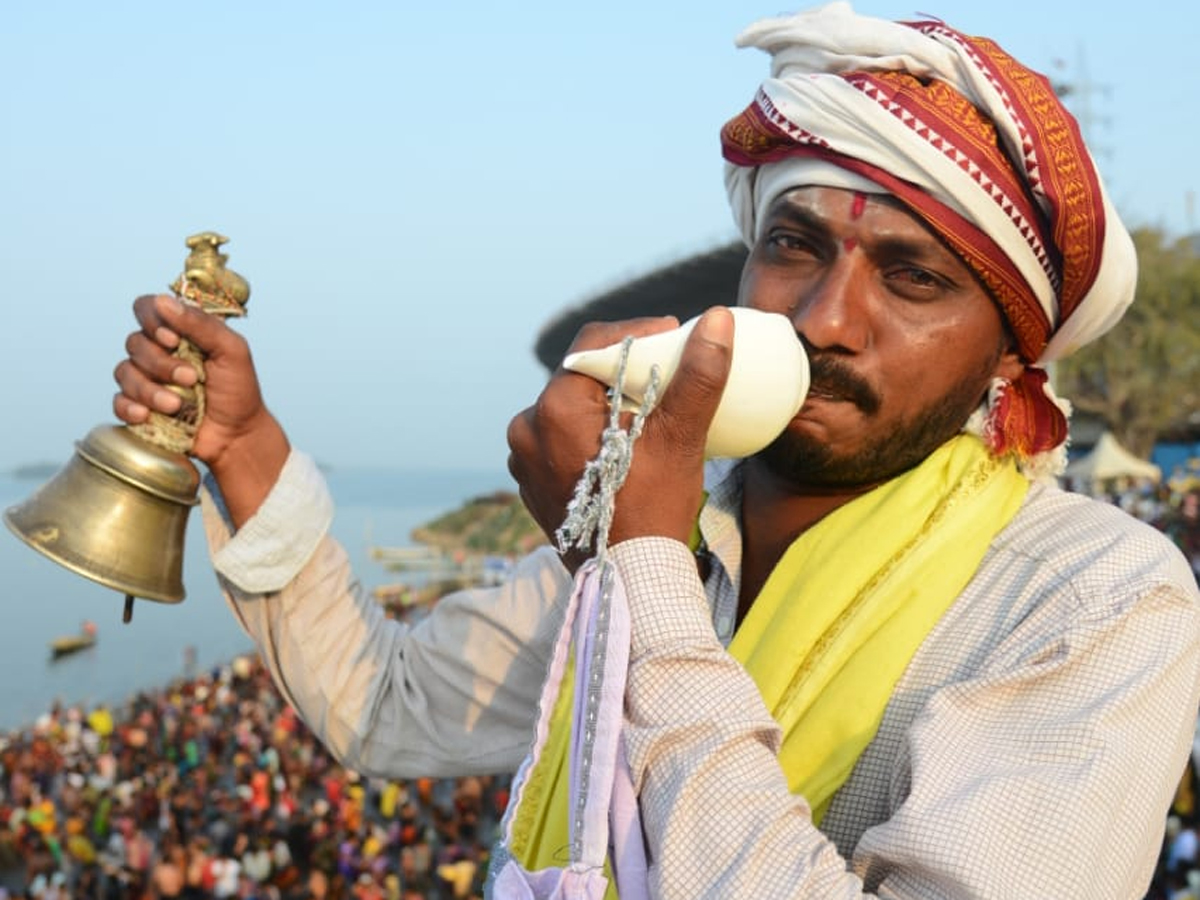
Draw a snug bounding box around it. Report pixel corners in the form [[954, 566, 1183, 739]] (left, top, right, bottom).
[[4, 232, 250, 622]]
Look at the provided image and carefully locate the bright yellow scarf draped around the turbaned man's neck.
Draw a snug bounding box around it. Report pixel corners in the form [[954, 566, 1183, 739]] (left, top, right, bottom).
[[511, 436, 1028, 898]]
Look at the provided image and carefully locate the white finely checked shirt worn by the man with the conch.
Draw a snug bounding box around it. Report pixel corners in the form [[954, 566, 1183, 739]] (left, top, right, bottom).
[[204, 454, 1200, 900]]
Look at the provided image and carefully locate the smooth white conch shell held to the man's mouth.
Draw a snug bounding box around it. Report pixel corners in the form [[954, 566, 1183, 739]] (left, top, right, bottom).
[[563, 306, 809, 458]]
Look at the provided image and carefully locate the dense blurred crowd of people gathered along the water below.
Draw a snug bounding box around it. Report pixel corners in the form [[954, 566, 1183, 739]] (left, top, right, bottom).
[[0, 460, 1200, 900]]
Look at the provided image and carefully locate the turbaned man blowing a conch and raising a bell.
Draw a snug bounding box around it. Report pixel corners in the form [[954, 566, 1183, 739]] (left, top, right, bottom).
[[114, 5, 1200, 898]]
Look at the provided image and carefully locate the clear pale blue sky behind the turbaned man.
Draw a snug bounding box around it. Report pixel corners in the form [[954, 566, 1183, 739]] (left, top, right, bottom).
[[0, 0, 1200, 472]]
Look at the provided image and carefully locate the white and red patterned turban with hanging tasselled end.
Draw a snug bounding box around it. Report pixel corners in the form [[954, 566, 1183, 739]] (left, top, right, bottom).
[[721, 2, 1138, 457]]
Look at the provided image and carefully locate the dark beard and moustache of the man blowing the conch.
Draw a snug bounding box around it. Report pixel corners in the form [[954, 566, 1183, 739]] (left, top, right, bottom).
[[758, 354, 995, 488]]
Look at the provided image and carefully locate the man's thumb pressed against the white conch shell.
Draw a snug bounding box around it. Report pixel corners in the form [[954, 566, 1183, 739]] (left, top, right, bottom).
[[655, 306, 733, 454]]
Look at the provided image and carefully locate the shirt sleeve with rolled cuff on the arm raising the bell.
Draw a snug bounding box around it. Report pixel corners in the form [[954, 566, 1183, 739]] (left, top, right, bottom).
[[202, 452, 571, 778]]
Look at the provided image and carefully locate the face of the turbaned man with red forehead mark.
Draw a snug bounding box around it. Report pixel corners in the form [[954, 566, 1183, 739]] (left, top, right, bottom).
[[739, 187, 1021, 487]]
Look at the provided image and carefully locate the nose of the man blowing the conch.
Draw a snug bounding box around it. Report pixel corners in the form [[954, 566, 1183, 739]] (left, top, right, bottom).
[[792, 260, 871, 353]]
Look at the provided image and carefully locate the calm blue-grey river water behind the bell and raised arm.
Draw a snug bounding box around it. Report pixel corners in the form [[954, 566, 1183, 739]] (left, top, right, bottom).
[[0, 469, 512, 730]]
